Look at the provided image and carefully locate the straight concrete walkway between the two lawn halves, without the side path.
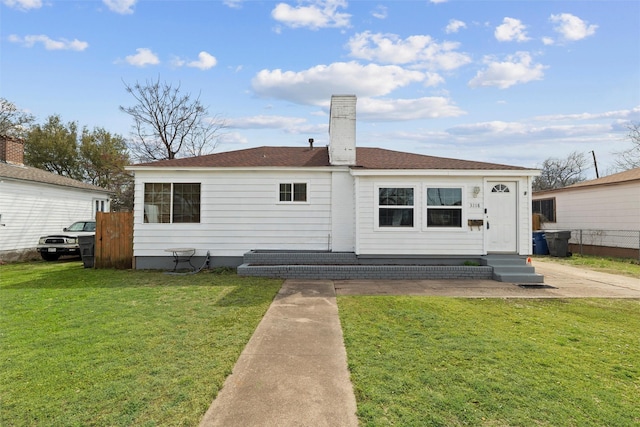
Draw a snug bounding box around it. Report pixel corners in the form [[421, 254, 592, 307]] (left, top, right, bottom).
[[200, 280, 358, 427]]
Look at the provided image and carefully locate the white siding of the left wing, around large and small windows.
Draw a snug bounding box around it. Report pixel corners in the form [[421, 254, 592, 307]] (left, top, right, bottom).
[[134, 170, 331, 256]]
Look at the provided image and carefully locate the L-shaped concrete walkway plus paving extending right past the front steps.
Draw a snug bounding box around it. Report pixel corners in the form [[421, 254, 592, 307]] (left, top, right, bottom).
[[200, 260, 640, 427]]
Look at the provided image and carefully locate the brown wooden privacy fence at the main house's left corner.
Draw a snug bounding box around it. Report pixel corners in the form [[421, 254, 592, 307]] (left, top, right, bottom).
[[95, 212, 133, 269]]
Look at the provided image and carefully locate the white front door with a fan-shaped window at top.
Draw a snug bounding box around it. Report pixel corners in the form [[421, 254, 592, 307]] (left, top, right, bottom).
[[486, 181, 518, 253]]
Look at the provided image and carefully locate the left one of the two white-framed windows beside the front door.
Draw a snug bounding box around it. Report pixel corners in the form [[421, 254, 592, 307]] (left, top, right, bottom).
[[378, 187, 414, 227]]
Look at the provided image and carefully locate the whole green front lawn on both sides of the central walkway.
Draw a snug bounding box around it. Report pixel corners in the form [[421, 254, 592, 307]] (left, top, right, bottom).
[[0, 262, 640, 427]]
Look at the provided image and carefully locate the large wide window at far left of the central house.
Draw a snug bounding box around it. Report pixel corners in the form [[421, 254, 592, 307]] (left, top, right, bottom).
[[144, 183, 200, 223]]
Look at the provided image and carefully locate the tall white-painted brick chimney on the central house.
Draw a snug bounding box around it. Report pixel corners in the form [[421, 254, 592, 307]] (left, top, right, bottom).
[[329, 95, 356, 166]]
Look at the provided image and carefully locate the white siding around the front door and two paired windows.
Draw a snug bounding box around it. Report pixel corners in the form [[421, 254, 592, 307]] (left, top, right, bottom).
[[356, 175, 531, 256]]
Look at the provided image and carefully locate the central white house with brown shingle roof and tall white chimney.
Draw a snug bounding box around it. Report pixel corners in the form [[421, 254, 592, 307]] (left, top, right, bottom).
[[129, 95, 539, 268]]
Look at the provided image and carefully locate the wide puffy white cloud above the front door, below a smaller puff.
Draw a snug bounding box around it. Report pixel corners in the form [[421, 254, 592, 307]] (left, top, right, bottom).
[[469, 52, 547, 89]]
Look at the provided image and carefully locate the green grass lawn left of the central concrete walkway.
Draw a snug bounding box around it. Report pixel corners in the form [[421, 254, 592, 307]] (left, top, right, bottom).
[[0, 262, 281, 426]]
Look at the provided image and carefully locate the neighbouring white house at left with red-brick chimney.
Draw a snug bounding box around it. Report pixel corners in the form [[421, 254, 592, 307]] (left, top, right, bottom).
[[0, 138, 109, 261]]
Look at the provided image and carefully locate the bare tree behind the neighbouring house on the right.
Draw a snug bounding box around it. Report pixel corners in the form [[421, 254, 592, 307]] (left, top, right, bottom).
[[533, 151, 588, 191]]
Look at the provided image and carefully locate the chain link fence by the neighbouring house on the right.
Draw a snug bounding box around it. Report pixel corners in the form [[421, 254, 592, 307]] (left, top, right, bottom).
[[569, 229, 640, 260]]
